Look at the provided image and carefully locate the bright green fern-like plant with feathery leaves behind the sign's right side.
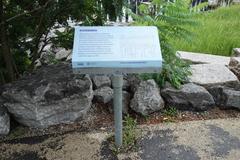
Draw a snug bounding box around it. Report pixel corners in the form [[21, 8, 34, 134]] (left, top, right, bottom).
[[131, 0, 198, 88]]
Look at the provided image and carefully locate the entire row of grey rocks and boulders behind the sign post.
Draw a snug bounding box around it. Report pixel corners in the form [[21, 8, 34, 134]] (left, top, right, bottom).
[[0, 51, 240, 135]]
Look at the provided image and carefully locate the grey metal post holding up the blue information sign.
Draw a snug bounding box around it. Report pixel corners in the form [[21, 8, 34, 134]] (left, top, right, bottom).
[[112, 74, 123, 147]]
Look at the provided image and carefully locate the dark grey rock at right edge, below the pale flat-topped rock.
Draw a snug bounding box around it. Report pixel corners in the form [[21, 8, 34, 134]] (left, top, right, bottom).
[[208, 86, 240, 109]]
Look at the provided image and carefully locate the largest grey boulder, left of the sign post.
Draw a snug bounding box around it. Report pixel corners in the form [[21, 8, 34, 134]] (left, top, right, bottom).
[[3, 64, 93, 128]]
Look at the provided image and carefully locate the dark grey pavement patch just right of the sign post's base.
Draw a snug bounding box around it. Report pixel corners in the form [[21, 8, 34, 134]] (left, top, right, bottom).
[[140, 129, 200, 160]]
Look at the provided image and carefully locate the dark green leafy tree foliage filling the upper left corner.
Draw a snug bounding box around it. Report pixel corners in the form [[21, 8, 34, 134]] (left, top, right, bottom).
[[0, 0, 124, 83]]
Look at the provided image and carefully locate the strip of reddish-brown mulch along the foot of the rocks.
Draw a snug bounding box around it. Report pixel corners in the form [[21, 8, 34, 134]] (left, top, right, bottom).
[[0, 104, 240, 143]]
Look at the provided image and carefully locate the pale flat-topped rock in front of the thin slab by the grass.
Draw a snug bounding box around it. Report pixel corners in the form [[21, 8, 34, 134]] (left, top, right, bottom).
[[189, 64, 239, 87]]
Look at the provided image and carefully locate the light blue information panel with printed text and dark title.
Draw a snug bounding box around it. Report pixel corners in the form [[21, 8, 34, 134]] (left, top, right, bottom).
[[72, 27, 162, 72]]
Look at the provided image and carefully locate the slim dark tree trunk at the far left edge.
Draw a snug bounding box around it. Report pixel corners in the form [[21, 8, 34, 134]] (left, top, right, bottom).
[[0, 0, 16, 81]]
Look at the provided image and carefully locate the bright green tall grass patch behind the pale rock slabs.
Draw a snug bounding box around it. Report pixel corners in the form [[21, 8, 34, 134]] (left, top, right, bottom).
[[171, 5, 240, 56]]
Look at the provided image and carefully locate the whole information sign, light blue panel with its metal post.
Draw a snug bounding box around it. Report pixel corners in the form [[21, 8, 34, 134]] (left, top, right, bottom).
[[72, 27, 162, 147]]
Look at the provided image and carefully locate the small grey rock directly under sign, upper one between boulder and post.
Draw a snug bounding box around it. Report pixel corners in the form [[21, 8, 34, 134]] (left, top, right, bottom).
[[92, 76, 111, 89]]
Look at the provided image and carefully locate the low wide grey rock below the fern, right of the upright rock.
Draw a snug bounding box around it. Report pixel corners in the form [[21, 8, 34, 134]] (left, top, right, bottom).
[[161, 83, 215, 110]]
